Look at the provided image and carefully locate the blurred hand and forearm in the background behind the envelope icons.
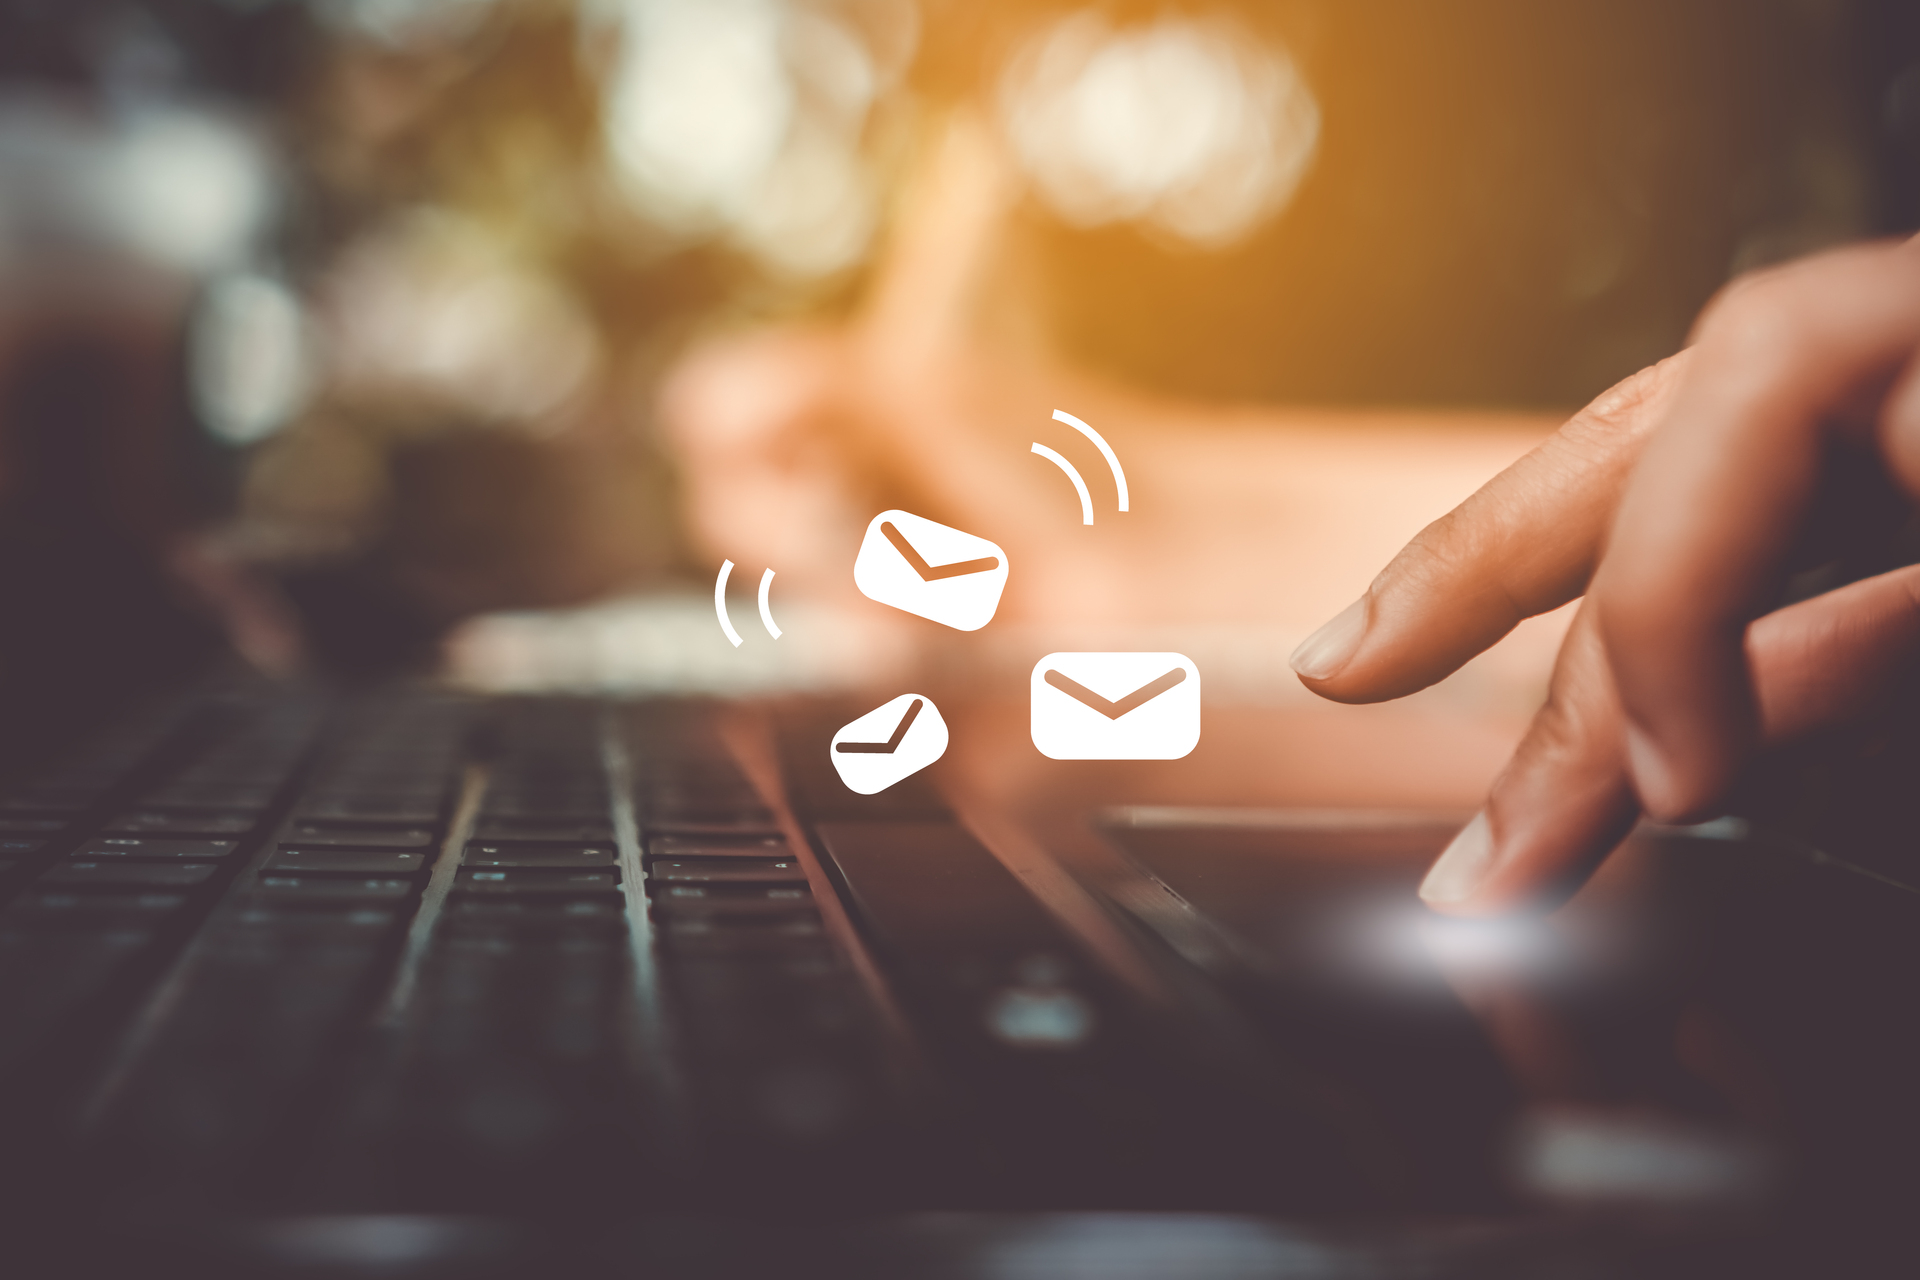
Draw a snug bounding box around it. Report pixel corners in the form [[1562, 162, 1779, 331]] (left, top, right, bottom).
[[657, 111, 1557, 660]]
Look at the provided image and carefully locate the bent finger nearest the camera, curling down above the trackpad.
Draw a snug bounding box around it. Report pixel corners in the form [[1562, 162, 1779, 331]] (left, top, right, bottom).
[[1592, 244, 1920, 819]]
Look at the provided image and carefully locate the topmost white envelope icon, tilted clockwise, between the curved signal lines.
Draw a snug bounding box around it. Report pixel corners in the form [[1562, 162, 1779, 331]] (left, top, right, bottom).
[[852, 510, 1006, 631]]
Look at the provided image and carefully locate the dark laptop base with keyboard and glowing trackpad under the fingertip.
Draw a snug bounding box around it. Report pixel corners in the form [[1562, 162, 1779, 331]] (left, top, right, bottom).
[[0, 660, 1920, 1276]]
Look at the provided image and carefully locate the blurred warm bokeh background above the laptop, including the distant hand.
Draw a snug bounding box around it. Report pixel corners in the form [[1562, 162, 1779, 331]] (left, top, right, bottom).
[[0, 0, 1920, 766]]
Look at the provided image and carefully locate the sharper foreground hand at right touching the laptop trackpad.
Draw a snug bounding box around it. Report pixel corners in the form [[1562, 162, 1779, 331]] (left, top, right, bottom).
[[1292, 240, 1920, 913]]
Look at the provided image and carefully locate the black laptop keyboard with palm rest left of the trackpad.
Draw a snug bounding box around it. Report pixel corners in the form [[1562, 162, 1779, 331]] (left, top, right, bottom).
[[0, 685, 1413, 1219]]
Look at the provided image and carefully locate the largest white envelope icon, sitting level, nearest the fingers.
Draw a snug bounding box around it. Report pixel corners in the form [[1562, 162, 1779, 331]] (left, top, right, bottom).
[[1033, 652, 1200, 760]]
